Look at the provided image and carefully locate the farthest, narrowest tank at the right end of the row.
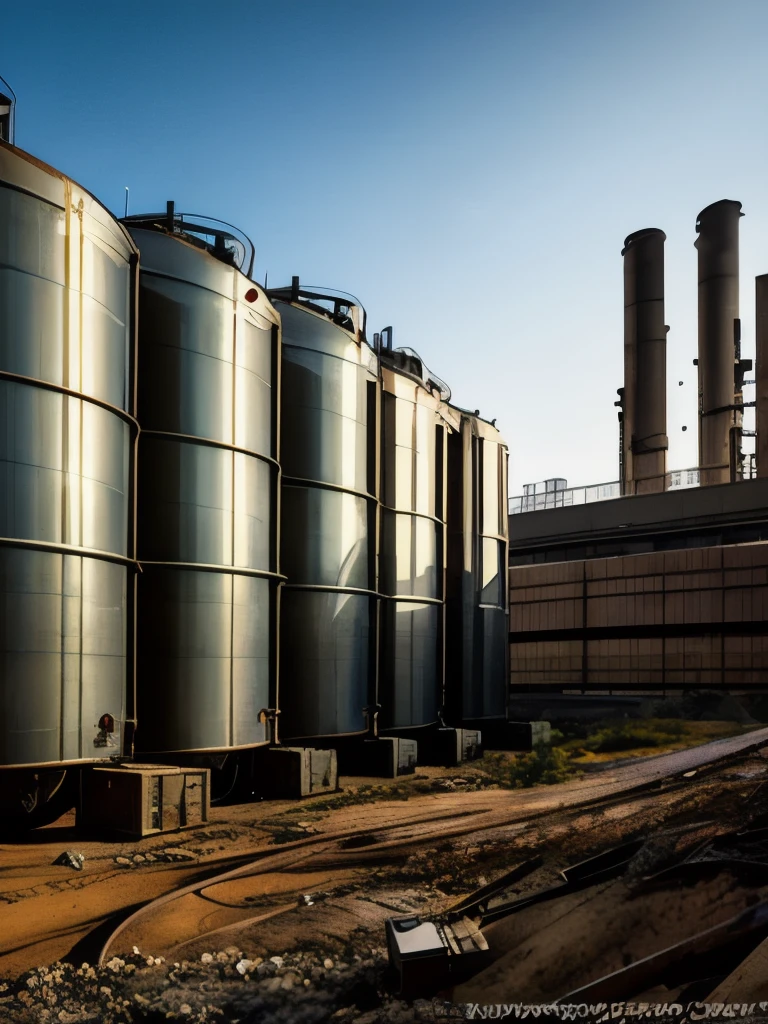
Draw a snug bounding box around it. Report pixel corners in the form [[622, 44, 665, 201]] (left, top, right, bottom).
[[445, 411, 509, 725]]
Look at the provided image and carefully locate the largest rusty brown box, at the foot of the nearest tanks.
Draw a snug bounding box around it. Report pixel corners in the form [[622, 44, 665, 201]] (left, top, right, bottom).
[[77, 765, 211, 839]]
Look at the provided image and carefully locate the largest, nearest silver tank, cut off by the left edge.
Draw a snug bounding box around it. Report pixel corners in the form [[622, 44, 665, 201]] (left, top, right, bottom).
[[0, 142, 136, 766]]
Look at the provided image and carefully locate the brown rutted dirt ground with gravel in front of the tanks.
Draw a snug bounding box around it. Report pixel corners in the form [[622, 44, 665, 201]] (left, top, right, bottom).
[[0, 733, 768, 1024]]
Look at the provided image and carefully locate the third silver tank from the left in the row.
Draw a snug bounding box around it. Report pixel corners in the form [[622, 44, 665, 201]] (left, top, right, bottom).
[[271, 290, 378, 738]]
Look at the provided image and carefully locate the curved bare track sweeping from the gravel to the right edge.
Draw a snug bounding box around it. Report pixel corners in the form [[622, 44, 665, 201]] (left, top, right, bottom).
[[91, 729, 768, 963]]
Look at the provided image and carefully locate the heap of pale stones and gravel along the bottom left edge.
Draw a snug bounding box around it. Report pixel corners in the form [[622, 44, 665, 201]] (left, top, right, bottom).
[[0, 946, 421, 1024]]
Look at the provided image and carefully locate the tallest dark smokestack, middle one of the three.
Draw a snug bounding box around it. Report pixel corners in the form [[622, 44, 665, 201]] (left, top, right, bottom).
[[694, 199, 742, 485]]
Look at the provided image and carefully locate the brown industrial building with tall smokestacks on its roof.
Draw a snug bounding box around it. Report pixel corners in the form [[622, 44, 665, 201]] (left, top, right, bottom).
[[509, 200, 768, 702]]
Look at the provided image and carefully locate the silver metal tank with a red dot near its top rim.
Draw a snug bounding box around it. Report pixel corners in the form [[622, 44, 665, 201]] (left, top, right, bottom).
[[129, 214, 280, 753]]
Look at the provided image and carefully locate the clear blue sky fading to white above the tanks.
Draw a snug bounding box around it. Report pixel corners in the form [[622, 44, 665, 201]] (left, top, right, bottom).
[[0, 0, 768, 494]]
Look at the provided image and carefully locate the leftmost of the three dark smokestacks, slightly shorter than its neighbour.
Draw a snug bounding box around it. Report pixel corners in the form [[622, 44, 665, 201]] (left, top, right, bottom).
[[622, 227, 669, 495]]
